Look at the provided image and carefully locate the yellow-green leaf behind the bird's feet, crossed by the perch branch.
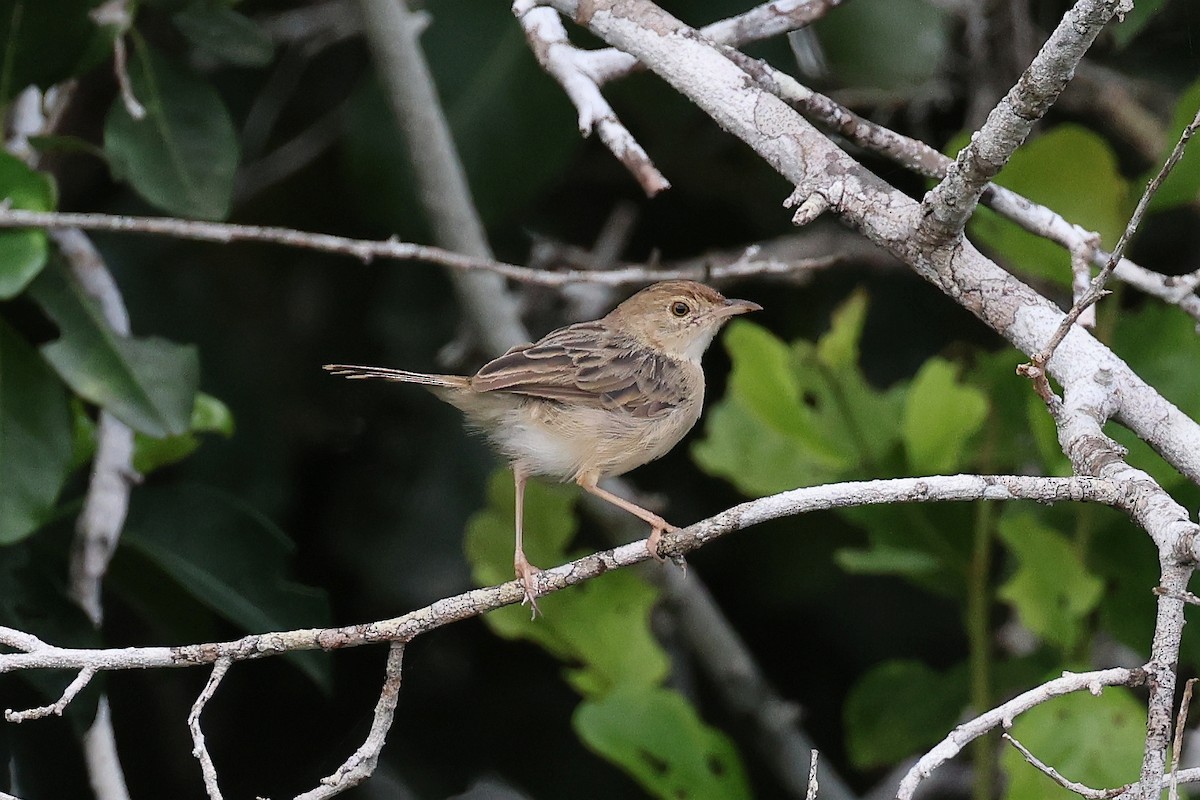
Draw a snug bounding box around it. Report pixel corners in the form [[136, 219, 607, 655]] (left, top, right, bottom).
[[466, 470, 670, 697]]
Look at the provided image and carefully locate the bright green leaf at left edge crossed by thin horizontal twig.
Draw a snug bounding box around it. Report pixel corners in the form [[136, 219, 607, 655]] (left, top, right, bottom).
[[0, 152, 56, 300]]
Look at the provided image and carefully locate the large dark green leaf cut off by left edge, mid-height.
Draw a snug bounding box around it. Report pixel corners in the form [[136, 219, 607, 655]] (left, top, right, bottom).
[[0, 319, 72, 545]]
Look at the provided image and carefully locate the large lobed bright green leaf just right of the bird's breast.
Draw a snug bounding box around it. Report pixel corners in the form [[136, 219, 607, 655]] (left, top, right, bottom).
[[692, 295, 904, 494]]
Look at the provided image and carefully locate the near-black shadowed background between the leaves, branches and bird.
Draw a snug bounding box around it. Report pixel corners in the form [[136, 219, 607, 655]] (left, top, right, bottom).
[[7, 0, 1200, 800]]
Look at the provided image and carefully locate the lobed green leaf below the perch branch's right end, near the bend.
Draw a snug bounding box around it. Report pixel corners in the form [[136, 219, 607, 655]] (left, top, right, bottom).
[[996, 511, 1104, 651]]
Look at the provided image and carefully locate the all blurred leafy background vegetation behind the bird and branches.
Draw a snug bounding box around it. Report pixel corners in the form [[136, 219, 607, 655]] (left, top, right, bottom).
[[7, 0, 1200, 800]]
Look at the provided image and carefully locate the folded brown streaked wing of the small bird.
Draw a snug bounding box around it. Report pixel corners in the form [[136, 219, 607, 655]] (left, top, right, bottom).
[[470, 323, 685, 417]]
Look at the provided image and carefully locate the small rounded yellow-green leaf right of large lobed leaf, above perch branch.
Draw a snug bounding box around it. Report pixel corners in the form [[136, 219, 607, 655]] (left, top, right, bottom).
[[901, 359, 988, 475]]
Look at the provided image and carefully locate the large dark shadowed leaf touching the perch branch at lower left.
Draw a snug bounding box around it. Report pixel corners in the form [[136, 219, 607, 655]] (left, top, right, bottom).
[[121, 485, 330, 687]]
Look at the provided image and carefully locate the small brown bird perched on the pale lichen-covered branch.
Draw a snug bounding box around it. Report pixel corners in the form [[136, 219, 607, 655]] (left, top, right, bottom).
[[325, 281, 762, 612]]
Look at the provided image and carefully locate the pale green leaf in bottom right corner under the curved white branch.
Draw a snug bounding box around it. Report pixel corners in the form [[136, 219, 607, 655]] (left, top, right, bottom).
[[1001, 686, 1146, 800]]
